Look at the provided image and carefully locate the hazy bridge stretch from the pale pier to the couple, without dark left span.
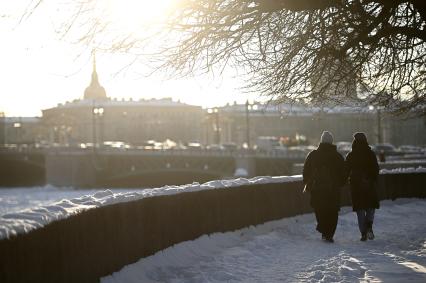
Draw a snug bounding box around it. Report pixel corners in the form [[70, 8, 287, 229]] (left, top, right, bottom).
[[46, 149, 305, 187]]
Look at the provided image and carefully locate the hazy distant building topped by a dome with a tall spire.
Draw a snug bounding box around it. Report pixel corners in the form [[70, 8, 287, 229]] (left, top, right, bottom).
[[42, 55, 203, 145]]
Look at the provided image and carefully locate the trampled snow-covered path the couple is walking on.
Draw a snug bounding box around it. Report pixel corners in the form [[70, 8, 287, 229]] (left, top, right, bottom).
[[101, 199, 426, 283]]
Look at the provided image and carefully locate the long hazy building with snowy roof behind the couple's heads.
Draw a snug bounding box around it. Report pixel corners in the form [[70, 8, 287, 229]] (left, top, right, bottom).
[[203, 104, 426, 146]]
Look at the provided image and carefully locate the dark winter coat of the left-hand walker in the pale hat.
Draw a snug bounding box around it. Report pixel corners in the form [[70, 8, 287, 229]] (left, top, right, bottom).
[[303, 143, 346, 210]]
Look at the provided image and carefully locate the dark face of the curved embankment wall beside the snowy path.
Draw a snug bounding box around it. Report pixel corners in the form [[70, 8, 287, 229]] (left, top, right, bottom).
[[0, 173, 426, 282]]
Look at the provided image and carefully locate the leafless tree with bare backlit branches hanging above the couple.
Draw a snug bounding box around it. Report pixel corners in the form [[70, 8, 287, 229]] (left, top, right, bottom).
[[20, 0, 426, 115]]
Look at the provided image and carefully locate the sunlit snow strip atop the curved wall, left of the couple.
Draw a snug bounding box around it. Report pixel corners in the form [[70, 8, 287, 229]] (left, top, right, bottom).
[[0, 175, 302, 239]]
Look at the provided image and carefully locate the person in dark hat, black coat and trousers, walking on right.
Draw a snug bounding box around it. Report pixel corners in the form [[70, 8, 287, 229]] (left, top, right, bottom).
[[345, 133, 380, 241]]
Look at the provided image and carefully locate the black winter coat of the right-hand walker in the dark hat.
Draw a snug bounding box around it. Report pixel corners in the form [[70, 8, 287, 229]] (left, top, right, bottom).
[[345, 140, 380, 211]]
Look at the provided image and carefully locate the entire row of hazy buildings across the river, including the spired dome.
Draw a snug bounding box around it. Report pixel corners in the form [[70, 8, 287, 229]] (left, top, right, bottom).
[[10, 55, 426, 150]]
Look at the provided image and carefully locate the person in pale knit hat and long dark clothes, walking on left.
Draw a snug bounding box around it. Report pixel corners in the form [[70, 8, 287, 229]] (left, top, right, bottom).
[[303, 131, 346, 242]]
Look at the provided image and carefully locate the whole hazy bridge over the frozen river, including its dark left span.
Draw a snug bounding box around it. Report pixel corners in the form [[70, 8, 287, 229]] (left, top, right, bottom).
[[0, 146, 305, 188]]
